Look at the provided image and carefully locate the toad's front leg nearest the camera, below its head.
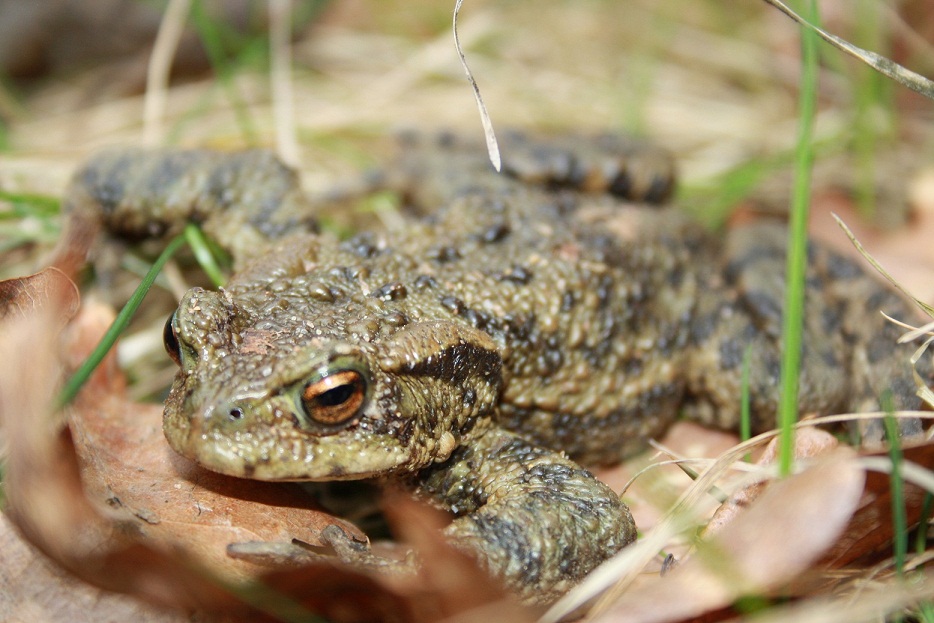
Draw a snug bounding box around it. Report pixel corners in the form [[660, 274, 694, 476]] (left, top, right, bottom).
[[417, 428, 636, 602]]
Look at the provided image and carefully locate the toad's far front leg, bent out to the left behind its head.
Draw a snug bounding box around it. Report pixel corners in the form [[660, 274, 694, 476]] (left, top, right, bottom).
[[66, 148, 316, 266]]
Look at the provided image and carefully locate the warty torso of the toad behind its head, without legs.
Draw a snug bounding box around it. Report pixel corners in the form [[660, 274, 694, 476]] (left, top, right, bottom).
[[376, 178, 703, 462]]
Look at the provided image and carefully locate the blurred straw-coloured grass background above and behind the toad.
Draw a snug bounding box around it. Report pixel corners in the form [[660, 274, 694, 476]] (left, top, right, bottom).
[[0, 0, 934, 205]]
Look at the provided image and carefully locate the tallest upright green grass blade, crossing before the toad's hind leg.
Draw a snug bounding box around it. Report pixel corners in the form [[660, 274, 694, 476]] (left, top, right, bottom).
[[779, 0, 818, 475]]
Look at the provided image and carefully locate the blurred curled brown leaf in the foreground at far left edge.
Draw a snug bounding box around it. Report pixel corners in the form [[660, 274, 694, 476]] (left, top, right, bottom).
[[0, 272, 249, 607]]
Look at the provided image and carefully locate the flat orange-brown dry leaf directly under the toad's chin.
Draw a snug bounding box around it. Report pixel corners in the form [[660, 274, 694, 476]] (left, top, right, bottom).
[[70, 398, 366, 580]]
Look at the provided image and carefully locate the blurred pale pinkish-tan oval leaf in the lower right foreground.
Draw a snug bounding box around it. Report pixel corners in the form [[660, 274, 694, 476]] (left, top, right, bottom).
[[599, 448, 864, 623]]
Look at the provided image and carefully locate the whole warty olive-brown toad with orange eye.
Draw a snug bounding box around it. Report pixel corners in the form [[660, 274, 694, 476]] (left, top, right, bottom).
[[64, 136, 928, 601]]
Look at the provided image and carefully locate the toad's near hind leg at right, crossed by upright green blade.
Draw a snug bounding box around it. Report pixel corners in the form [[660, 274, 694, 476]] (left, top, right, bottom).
[[687, 224, 930, 438]]
